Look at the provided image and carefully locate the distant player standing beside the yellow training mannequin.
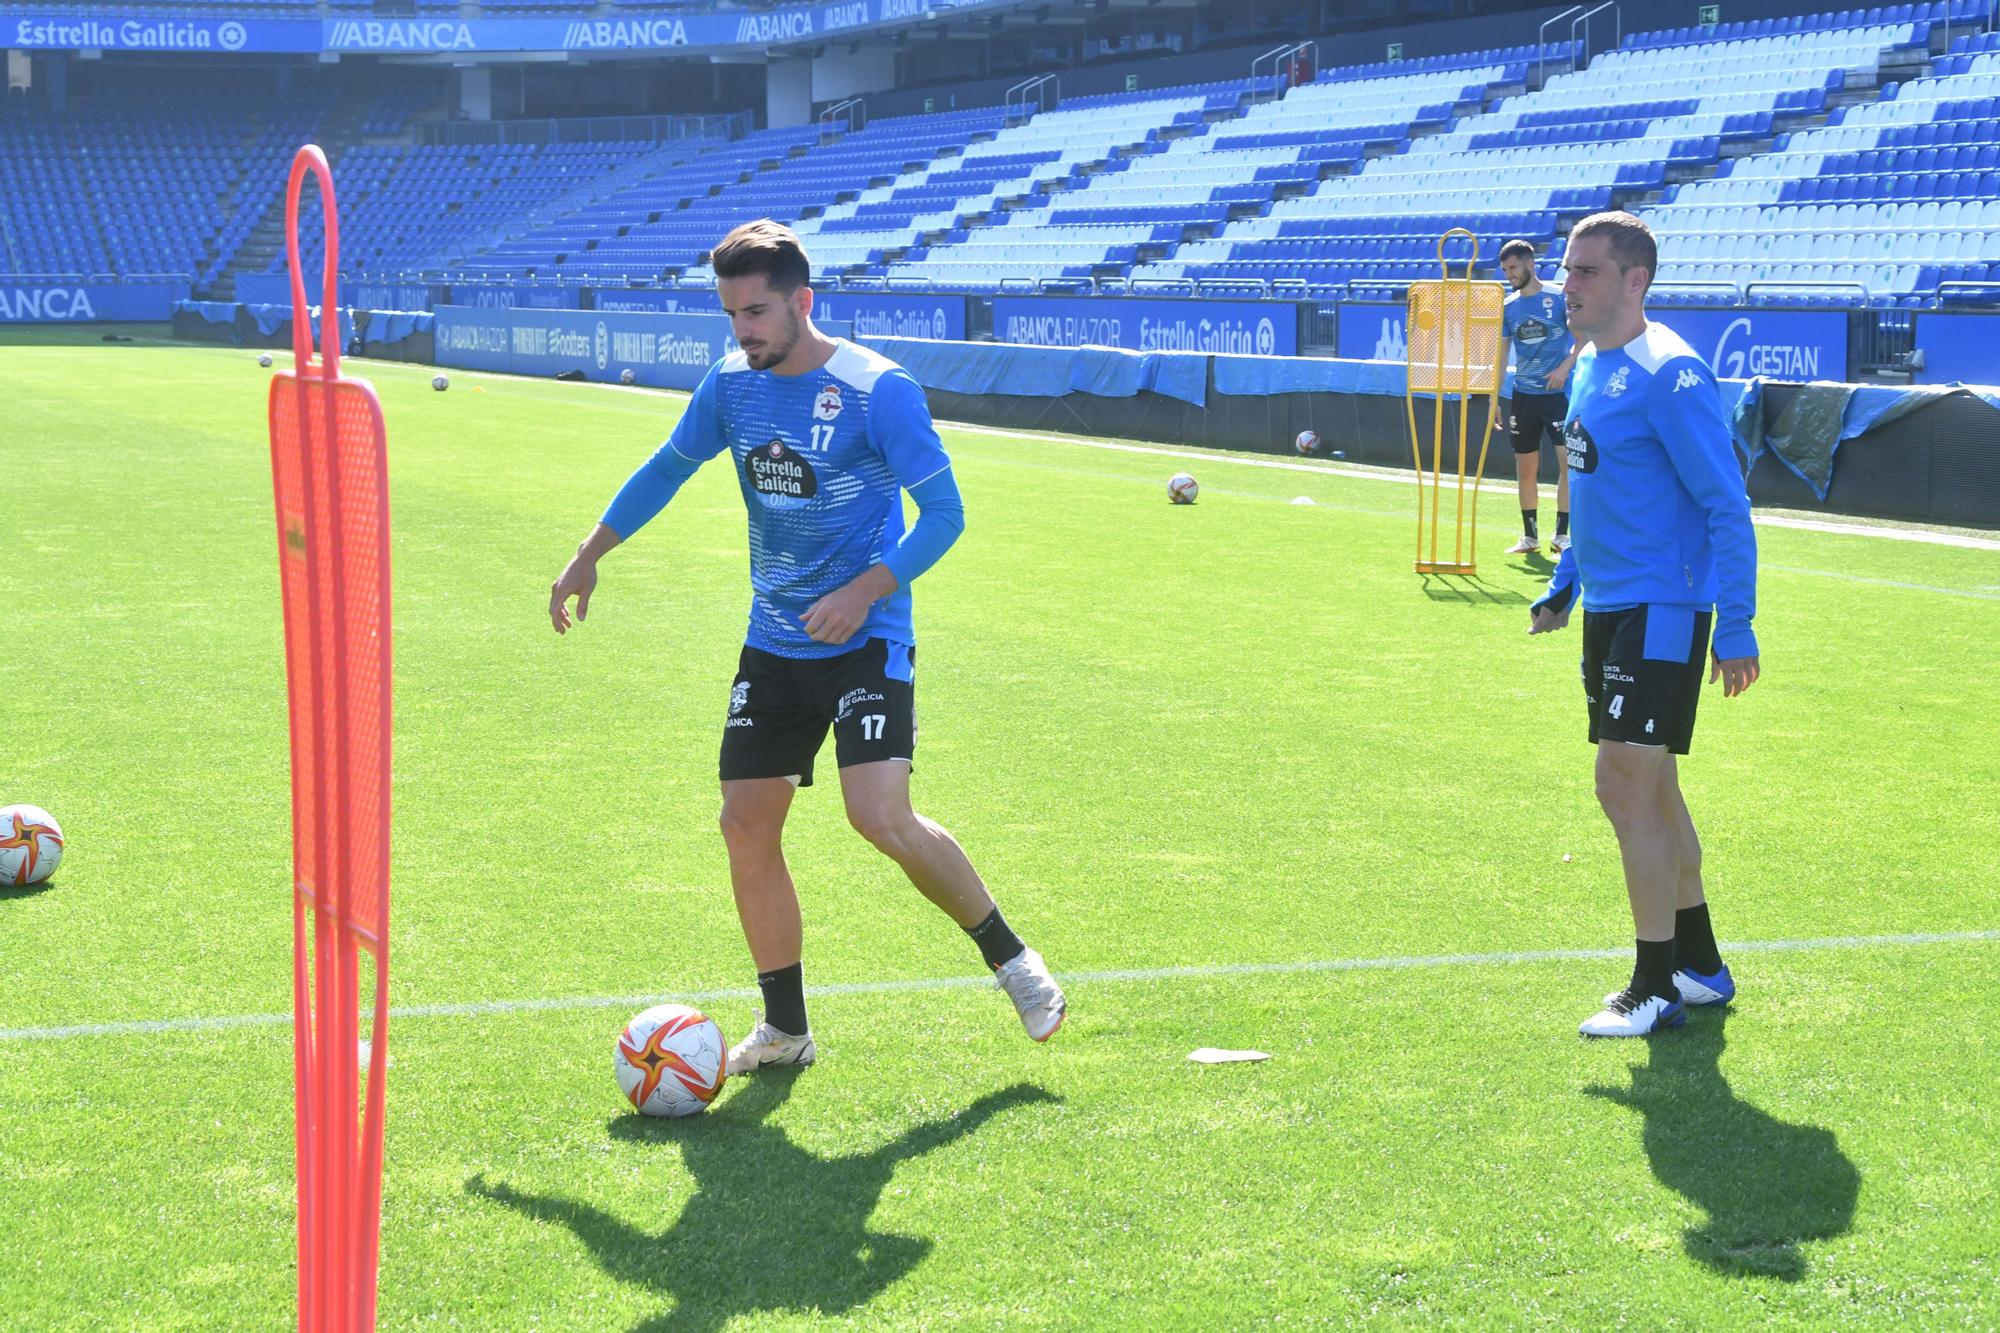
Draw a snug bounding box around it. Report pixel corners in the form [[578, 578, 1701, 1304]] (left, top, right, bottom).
[[1494, 240, 1576, 556]]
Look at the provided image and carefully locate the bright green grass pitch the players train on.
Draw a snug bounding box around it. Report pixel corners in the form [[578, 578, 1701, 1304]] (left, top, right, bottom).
[[0, 324, 2000, 1333]]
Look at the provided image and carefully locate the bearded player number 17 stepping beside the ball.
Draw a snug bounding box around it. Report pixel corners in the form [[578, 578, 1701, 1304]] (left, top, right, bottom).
[[548, 220, 1064, 1075]]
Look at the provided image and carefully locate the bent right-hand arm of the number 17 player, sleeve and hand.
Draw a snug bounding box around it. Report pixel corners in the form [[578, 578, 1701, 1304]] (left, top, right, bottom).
[[804, 370, 966, 644]]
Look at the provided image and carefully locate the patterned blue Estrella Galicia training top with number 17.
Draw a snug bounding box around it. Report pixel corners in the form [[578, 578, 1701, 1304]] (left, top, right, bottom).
[[602, 340, 966, 656]]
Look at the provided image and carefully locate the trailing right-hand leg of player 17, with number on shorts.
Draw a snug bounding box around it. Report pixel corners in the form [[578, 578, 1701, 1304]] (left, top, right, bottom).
[[834, 640, 1066, 1041]]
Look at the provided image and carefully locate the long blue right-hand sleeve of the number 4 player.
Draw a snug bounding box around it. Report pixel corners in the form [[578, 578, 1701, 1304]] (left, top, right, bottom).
[[1646, 356, 1758, 658]]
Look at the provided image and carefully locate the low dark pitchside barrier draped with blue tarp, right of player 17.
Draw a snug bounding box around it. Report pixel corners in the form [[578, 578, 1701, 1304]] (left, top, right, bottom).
[[866, 338, 2000, 526]]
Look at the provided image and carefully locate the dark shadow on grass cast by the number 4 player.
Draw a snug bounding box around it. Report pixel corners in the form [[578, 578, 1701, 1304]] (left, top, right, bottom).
[[1584, 1011, 1862, 1283]]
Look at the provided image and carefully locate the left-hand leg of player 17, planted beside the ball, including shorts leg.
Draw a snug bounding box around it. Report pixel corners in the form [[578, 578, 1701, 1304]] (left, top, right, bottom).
[[720, 648, 826, 1075]]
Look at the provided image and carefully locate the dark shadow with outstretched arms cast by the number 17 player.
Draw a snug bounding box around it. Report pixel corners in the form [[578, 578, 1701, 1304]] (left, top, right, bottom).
[[466, 1069, 1060, 1333]]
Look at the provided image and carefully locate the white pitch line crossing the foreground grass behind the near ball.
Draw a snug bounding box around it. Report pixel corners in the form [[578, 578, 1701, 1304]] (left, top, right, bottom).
[[0, 931, 2000, 1041]]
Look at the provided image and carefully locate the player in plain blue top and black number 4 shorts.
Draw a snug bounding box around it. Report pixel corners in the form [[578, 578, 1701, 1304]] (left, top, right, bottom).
[[1528, 212, 1758, 1037]]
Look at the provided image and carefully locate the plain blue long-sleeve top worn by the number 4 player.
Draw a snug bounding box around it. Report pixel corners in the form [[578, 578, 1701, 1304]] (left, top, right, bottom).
[[1538, 324, 1758, 658]]
